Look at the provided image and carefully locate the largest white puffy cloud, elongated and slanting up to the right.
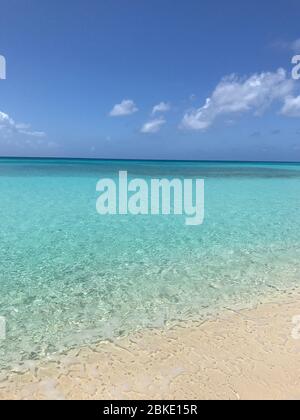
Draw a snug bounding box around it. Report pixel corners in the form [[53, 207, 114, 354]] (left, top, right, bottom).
[[181, 69, 294, 130]]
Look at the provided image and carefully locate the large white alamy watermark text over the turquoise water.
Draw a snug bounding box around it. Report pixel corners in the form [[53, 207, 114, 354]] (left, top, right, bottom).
[[96, 171, 204, 226]]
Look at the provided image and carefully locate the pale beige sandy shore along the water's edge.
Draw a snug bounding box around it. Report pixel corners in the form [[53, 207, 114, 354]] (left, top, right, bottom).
[[0, 291, 300, 399]]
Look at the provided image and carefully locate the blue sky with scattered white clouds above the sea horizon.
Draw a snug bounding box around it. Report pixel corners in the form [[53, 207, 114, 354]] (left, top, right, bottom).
[[0, 0, 300, 160]]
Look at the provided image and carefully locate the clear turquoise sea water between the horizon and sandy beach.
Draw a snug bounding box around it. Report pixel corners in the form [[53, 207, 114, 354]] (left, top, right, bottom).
[[0, 159, 300, 367]]
